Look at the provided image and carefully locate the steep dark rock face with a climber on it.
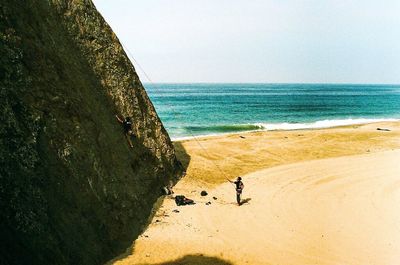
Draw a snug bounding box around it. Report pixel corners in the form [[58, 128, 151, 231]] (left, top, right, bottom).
[[0, 0, 181, 264]]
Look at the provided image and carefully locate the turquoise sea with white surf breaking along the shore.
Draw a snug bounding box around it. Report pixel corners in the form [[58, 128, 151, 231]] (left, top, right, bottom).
[[144, 83, 400, 140]]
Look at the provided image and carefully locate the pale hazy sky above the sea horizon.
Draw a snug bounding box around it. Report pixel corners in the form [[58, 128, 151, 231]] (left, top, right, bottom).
[[93, 0, 400, 84]]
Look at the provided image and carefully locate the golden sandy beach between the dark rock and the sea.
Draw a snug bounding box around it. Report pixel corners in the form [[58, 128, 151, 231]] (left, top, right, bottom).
[[109, 122, 400, 265]]
